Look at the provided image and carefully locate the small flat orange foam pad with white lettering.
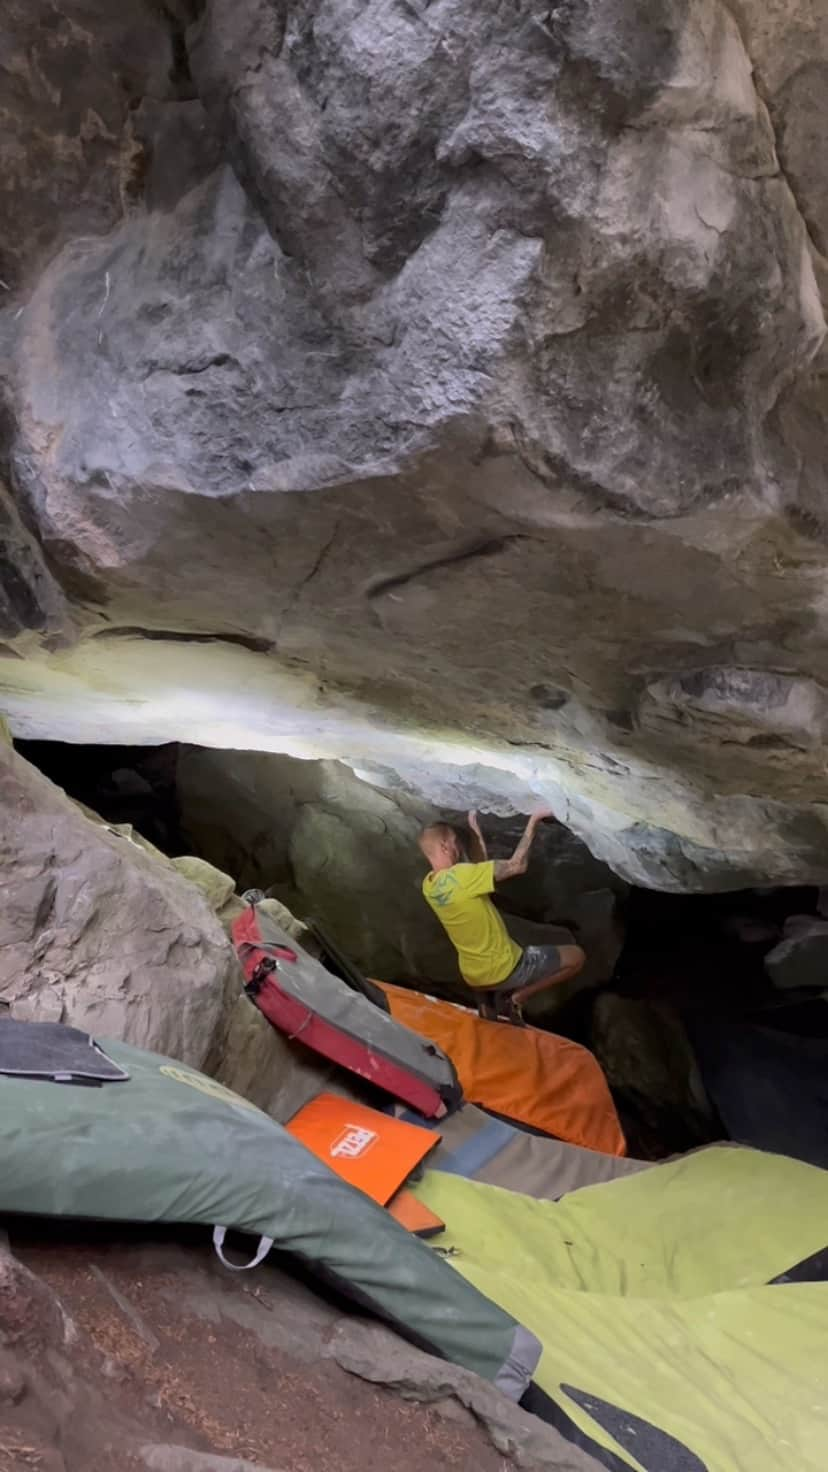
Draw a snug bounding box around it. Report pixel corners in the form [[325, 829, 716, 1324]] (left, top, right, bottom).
[[284, 1094, 441, 1206]]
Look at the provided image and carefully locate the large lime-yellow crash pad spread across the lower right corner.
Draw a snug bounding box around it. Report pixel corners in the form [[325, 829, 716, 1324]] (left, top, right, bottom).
[[415, 1147, 828, 1472]]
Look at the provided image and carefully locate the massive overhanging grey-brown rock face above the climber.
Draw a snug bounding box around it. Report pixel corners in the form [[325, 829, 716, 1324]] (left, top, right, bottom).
[[0, 0, 828, 888]]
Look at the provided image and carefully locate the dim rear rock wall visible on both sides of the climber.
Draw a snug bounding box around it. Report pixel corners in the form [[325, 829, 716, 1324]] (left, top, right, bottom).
[[175, 748, 628, 1002]]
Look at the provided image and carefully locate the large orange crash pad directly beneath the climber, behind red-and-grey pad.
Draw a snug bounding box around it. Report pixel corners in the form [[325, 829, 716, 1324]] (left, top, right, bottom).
[[382, 983, 626, 1156]]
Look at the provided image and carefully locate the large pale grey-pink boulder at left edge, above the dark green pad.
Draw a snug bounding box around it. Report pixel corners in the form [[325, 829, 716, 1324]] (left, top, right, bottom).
[[0, 745, 240, 1067]]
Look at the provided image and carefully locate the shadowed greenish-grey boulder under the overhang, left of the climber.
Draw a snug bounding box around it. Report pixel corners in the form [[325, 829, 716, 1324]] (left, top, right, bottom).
[[178, 749, 458, 983]]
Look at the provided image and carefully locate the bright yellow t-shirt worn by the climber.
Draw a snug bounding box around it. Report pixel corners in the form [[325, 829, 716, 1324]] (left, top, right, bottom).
[[423, 860, 523, 986]]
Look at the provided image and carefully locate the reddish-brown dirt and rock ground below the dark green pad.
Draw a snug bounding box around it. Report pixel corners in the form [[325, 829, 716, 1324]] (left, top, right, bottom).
[[0, 1231, 511, 1472]]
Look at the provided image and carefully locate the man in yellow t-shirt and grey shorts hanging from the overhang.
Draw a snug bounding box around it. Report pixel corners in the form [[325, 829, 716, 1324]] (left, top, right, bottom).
[[418, 808, 586, 1020]]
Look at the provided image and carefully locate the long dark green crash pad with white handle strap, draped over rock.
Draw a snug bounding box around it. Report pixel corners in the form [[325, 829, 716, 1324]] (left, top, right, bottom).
[[0, 1022, 539, 1400]]
